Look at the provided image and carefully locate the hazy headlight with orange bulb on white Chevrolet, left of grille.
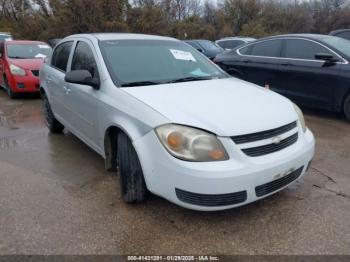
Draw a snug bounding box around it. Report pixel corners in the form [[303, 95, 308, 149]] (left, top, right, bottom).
[[155, 124, 229, 162]]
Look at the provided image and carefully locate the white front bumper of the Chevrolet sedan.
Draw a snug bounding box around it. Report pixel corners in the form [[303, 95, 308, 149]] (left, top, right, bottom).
[[134, 125, 315, 211]]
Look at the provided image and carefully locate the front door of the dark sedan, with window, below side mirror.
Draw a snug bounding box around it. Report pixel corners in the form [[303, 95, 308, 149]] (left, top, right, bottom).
[[278, 39, 341, 109]]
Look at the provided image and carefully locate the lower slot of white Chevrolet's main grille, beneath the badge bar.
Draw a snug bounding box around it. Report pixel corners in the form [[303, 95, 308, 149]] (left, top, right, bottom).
[[242, 133, 298, 157]]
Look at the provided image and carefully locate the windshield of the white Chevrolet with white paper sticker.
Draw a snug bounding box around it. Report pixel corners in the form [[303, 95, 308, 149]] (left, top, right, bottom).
[[100, 40, 228, 86]]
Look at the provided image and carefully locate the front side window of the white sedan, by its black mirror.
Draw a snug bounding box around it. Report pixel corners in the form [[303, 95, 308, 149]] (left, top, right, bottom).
[[71, 42, 98, 78]]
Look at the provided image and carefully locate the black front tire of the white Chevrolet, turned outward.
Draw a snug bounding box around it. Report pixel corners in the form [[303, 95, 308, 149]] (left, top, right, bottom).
[[117, 132, 147, 203]]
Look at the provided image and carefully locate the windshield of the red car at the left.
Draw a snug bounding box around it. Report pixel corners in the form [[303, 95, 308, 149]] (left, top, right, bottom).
[[7, 43, 51, 59]]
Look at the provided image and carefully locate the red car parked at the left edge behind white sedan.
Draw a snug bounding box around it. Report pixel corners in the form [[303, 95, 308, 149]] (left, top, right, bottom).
[[0, 41, 52, 98]]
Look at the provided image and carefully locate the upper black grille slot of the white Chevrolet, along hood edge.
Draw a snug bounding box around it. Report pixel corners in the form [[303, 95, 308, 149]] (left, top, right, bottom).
[[231, 122, 297, 144]]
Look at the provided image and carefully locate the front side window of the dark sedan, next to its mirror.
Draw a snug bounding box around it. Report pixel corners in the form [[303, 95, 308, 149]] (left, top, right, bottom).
[[285, 39, 330, 60]]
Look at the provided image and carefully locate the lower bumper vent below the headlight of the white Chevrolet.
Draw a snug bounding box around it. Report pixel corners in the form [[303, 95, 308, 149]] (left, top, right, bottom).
[[175, 188, 247, 207]]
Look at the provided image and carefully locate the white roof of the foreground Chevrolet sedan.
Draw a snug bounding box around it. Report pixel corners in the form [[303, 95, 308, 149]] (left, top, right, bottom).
[[65, 33, 179, 41]]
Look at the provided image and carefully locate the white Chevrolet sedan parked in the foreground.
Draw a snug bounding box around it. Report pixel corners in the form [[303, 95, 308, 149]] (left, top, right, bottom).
[[40, 34, 315, 211]]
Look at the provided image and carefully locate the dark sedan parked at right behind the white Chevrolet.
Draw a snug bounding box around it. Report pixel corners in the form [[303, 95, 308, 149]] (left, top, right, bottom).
[[214, 34, 350, 120]]
